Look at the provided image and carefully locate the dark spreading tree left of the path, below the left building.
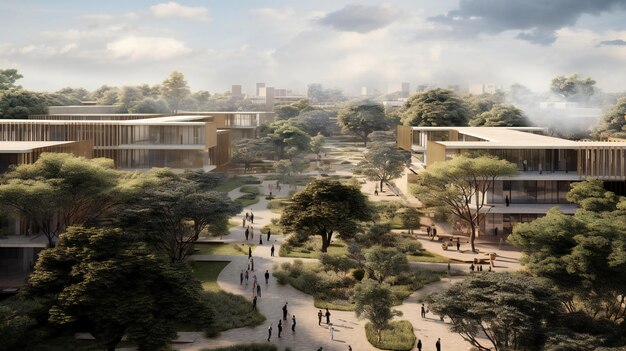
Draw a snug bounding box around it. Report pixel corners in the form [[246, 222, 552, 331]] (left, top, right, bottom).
[[121, 169, 241, 263]]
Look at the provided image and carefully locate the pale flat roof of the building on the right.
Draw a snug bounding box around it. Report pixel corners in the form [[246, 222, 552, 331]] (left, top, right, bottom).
[[412, 127, 626, 149]]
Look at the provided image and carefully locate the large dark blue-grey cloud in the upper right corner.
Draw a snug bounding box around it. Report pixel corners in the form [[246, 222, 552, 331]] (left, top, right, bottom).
[[430, 0, 626, 45]]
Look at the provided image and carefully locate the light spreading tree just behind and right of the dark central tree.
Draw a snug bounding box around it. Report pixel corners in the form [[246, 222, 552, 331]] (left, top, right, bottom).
[[354, 143, 411, 191]]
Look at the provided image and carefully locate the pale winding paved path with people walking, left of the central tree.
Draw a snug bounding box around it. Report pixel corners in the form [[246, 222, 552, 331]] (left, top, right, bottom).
[[174, 182, 470, 351]]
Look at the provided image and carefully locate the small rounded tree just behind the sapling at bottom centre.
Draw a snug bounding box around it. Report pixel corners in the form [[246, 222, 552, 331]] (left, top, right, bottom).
[[365, 246, 409, 283]]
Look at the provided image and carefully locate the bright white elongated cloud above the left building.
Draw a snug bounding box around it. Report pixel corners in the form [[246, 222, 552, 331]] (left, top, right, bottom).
[[106, 36, 191, 61]]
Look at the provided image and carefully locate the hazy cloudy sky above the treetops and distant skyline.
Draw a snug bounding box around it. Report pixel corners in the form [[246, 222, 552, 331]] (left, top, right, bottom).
[[0, 0, 626, 94]]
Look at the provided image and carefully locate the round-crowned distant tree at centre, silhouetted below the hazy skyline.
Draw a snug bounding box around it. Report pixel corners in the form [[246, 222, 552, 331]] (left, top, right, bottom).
[[337, 101, 389, 146]]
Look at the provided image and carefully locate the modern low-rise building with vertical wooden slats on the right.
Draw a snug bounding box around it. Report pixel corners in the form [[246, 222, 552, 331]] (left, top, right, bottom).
[[397, 126, 626, 234]]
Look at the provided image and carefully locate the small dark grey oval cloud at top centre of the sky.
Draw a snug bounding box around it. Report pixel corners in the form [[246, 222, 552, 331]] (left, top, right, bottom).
[[317, 3, 402, 33]]
